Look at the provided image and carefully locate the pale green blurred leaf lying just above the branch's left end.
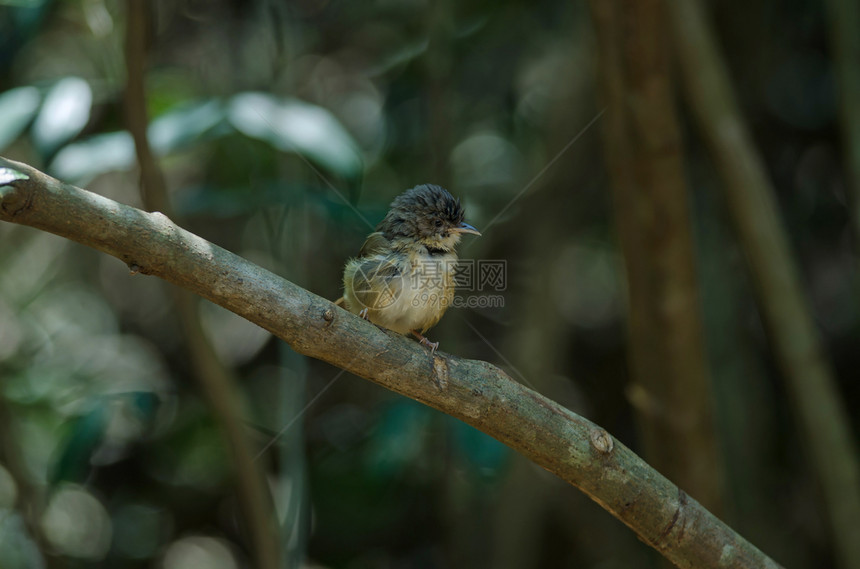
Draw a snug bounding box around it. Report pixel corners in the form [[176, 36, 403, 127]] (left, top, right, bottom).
[[48, 131, 135, 183]]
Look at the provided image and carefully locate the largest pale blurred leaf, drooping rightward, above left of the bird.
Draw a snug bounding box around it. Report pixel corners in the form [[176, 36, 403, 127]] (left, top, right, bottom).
[[228, 93, 363, 180]]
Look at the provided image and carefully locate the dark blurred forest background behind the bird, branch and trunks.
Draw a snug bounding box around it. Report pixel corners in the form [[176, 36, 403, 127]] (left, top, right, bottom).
[[0, 0, 860, 569]]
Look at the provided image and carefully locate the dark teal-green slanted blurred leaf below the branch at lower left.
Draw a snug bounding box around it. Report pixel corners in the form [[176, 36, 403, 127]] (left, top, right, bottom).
[[48, 405, 107, 484]]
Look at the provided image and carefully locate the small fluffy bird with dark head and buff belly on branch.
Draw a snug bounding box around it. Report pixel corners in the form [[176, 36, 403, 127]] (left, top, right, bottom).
[[337, 184, 481, 353]]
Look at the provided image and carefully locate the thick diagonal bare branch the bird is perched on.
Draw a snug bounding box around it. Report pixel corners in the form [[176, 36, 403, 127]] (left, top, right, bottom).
[[0, 158, 778, 568]]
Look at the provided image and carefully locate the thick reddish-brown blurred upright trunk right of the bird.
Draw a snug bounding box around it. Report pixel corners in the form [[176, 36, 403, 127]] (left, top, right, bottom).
[[591, 0, 723, 512]]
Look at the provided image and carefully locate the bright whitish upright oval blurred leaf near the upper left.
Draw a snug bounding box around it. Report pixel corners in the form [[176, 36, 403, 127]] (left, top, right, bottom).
[[32, 77, 93, 155]]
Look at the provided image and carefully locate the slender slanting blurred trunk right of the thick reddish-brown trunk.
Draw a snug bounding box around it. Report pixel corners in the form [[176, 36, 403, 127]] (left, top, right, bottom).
[[667, 0, 860, 568]]
